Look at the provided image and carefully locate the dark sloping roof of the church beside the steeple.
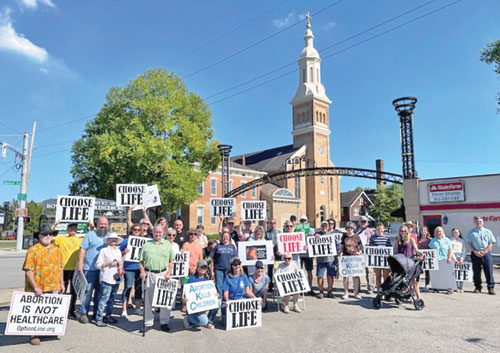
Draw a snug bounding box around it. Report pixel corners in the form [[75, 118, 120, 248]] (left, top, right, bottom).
[[231, 145, 299, 172]]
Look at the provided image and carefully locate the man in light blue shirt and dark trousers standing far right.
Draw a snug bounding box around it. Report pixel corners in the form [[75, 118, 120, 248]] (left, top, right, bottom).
[[465, 217, 496, 295]]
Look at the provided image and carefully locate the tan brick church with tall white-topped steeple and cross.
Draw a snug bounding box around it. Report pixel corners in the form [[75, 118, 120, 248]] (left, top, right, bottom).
[[181, 14, 341, 232]]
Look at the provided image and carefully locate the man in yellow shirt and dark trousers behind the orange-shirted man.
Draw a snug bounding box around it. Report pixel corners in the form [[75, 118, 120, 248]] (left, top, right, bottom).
[[54, 222, 82, 318]]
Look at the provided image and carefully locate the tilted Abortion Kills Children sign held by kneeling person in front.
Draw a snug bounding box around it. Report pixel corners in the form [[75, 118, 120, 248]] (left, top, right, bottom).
[[184, 281, 219, 314]]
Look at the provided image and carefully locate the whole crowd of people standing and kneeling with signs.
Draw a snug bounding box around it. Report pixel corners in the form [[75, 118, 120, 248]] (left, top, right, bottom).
[[23, 207, 495, 345]]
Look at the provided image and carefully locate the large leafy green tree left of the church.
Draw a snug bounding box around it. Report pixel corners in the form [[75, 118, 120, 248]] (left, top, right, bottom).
[[70, 69, 220, 211]]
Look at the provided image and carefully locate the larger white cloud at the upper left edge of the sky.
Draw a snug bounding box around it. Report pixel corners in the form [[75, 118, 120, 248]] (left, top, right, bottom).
[[0, 8, 49, 62]]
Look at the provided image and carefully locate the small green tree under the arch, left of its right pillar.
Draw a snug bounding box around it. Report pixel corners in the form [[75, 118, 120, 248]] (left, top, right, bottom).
[[370, 184, 403, 225]]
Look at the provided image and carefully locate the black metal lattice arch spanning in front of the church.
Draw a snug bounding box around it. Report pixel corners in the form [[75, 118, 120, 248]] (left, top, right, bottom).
[[224, 167, 403, 197]]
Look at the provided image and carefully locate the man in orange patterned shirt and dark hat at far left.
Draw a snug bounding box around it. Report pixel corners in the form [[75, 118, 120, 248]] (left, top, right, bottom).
[[23, 224, 64, 346]]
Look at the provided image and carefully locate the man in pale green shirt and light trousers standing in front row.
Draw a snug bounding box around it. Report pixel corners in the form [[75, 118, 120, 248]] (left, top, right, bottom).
[[139, 225, 174, 332]]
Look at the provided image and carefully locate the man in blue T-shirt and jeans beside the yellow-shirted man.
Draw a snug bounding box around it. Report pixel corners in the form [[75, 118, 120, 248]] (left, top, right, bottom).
[[78, 217, 108, 324]]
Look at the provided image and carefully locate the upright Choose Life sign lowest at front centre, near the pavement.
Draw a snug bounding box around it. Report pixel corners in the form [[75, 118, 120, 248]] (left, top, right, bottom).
[[226, 298, 262, 331]]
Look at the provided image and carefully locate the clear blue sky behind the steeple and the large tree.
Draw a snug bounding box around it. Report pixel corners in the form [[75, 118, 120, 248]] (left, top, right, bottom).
[[0, 0, 500, 201]]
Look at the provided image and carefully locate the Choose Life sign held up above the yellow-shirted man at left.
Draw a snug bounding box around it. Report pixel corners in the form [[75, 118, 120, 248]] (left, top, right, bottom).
[[56, 195, 95, 222]]
